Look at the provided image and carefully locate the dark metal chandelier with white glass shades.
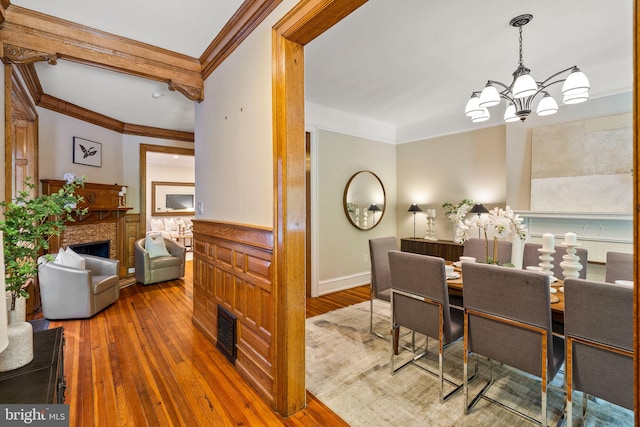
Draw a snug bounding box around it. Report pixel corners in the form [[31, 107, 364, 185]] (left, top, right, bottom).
[[464, 14, 589, 122]]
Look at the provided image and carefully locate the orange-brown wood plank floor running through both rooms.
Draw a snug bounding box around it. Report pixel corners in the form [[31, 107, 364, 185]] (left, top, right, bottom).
[[40, 263, 369, 427]]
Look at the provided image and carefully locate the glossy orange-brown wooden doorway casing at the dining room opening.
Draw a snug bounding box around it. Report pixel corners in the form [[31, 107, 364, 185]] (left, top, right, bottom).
[[272, 0, 366, 416]]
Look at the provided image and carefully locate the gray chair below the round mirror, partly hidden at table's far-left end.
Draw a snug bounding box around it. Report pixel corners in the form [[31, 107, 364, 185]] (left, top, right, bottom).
[[369, 237, 398, 339]]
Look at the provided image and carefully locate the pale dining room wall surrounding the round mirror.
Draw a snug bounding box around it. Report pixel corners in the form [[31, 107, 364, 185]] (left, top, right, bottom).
[[312, 130, 396, 294]]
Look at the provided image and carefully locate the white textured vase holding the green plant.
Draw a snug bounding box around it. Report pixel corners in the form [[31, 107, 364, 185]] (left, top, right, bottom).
[[0, 310, 33, 372]]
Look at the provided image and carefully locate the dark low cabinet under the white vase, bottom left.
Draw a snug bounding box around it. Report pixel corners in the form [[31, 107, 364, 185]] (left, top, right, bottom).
[[0, 328, 65, 404]]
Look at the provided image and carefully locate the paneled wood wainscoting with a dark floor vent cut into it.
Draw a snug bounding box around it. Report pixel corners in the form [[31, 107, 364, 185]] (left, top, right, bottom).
[[193, 220, 275, 404]]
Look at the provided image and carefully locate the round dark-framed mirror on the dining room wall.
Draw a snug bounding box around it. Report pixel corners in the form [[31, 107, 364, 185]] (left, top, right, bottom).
[[342, 171, 386, 230]]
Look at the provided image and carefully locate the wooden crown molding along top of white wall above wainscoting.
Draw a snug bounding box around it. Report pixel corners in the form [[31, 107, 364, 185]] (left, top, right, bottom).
[[200, 0, 282, 80]]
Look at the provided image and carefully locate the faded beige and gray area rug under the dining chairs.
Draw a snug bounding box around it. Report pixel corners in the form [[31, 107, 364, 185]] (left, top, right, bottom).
[[306, 301, 633, 427]]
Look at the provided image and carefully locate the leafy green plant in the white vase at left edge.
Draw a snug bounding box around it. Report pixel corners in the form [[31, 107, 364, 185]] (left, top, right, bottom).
[[0, 177, 87, 310]]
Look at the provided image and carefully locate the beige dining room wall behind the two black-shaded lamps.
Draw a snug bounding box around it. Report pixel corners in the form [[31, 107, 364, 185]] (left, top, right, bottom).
[[397, 125, 507, 240]]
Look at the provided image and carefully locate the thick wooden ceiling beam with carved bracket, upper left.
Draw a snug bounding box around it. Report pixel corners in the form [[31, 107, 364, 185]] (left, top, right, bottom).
[[0, 5, 204, 101]]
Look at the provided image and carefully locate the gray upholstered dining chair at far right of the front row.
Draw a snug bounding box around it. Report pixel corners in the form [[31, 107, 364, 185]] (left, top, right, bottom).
[[564, 278, 634, 425]]
